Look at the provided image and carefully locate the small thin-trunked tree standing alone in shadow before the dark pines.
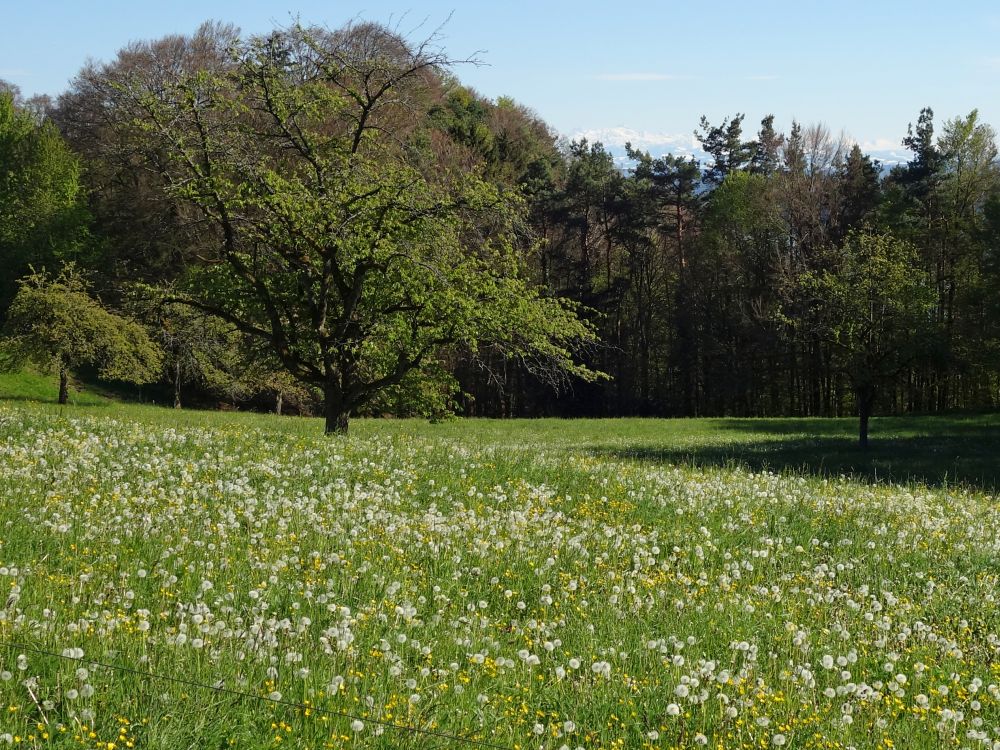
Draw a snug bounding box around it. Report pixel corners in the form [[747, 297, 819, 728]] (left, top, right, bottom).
[[794, 231, 936, 448]]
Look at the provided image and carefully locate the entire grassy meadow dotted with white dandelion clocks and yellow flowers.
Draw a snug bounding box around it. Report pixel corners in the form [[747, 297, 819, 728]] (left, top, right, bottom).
[[0, 400, 1000, 750]]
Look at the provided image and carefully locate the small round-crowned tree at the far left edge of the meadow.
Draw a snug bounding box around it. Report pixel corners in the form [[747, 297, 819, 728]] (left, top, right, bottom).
[[0, 265, 161, 404]]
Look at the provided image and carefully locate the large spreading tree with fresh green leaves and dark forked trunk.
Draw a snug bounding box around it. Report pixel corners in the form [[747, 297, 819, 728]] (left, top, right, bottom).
[[90, 24, 596, 432]]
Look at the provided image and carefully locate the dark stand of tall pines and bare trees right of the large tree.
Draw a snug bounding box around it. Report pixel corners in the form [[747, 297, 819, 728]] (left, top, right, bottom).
[[476, 108, 1000, 424]]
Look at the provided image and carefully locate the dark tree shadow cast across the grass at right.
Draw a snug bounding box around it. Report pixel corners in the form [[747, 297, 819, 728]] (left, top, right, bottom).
[[591, 416, 1000, 492]]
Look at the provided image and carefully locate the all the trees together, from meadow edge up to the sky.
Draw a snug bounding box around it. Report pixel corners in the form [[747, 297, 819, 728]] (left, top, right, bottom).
[[0, 23, 1000, 440]]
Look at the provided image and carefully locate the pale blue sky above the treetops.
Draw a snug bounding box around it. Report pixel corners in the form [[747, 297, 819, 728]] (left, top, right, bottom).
[[0, 0, 1000, 159]]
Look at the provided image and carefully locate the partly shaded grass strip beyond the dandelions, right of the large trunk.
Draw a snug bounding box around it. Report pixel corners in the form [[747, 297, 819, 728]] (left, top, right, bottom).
[[358, 415, 1000, 489]]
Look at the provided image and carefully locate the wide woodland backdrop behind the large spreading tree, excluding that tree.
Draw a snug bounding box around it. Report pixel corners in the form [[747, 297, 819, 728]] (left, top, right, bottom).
[[0, 19, 1000, 428]]
